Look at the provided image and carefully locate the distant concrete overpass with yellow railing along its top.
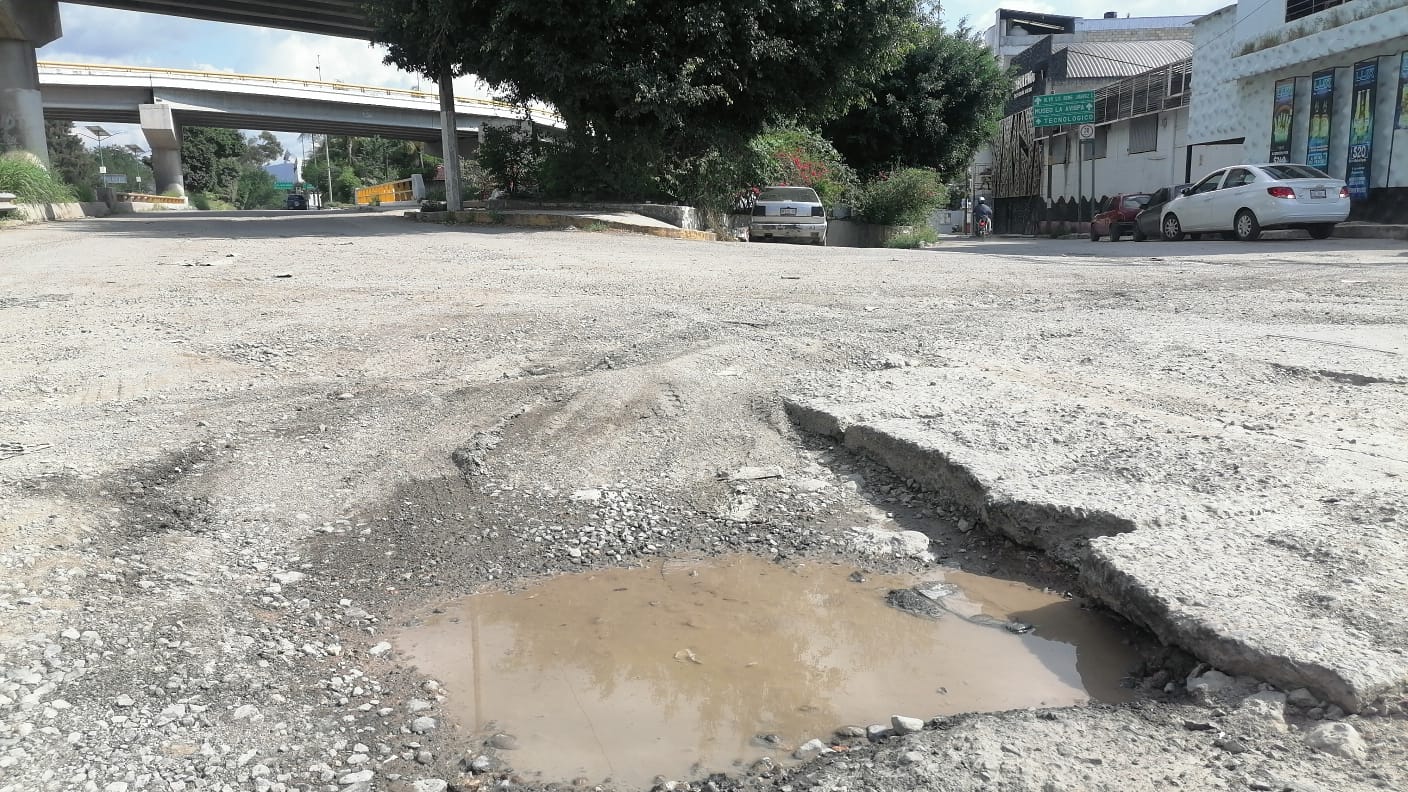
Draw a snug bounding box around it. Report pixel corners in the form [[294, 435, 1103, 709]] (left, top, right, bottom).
[[38, 62, 558, 192]]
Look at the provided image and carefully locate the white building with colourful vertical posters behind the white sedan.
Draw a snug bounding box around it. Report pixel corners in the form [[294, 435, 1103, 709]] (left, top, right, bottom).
[[1188, 0, 1408, 223]]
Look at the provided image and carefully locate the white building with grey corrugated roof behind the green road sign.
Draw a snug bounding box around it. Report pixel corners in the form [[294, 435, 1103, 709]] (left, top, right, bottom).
[[979, 10, 1197, 233]]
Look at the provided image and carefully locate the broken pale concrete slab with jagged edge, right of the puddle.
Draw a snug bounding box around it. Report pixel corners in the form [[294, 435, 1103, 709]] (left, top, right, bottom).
[[786, 368, 1408, 712]]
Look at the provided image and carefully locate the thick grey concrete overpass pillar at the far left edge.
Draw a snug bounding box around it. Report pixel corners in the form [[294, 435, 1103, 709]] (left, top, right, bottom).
[[0, 0, 63, 165]]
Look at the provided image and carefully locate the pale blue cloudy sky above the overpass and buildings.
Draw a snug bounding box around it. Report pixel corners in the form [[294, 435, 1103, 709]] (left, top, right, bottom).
[[39, 0, 1229, 156]]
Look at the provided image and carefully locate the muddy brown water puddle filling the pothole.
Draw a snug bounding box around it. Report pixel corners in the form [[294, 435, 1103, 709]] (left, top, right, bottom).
[[394, 555, 1136, 786]]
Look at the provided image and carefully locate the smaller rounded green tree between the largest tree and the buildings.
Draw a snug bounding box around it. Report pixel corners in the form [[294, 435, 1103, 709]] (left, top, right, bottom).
[[822, 21, 1011, 179]]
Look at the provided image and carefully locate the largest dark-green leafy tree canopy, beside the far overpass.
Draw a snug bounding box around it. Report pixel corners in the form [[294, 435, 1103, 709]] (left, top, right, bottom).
[[365, 0, 917, 189]]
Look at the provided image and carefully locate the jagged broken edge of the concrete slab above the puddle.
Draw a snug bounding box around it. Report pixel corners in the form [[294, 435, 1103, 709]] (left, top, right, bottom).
[[783, 396, 1408, 712]]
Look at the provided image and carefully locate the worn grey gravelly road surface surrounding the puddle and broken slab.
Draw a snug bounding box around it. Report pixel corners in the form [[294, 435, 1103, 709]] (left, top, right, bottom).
[[0, 214, 1408, 792]]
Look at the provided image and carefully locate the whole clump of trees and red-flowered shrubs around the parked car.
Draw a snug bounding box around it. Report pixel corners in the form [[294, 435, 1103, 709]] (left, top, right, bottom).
[[366, 0, 1010, 225]]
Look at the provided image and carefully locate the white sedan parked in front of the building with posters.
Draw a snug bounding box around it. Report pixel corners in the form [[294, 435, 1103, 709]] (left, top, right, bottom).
[[1159, 163, 1349, 242]]
